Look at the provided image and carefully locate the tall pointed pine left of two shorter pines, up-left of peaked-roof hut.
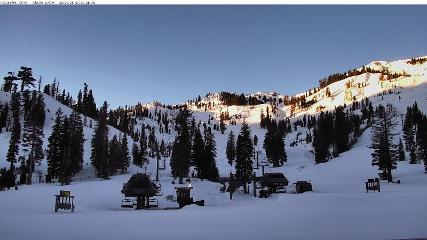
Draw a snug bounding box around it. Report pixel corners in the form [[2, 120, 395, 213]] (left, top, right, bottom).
[[90, 102, 111, 179]]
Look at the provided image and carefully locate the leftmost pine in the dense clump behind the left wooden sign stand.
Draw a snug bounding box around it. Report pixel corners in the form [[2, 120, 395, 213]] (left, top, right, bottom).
[[47, 108, 63, 179]]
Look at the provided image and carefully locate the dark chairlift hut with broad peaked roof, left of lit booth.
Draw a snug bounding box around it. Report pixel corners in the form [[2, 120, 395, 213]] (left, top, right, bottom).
[[122, 173, 160, 209]]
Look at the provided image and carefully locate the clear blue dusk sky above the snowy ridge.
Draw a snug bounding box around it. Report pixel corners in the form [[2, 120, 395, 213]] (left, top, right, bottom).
[[0, 5, 427, 108]]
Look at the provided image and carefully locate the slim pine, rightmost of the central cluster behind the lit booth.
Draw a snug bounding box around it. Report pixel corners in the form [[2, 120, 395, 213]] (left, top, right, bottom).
[[204, 128, 219, 181]]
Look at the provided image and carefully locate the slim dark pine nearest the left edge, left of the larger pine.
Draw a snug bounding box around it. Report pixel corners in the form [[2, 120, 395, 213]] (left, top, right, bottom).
[[6, 93, 21, 173]]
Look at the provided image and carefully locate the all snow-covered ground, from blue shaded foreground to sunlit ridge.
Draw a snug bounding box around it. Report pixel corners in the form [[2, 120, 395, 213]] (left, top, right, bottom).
[[0, 55, 427, 240]]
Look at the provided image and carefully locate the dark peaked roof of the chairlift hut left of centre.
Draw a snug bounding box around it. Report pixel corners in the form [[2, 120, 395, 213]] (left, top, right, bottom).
[[122, 173, 159, 197]]
